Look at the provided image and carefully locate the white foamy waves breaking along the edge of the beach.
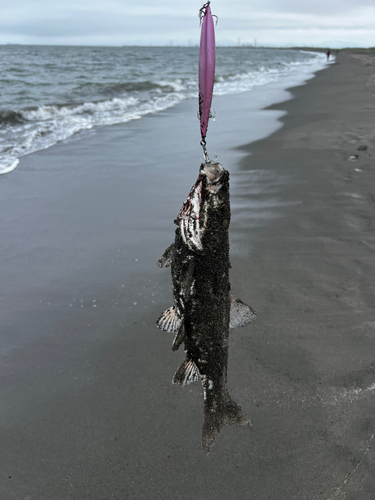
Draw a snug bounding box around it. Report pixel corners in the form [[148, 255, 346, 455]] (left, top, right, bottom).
[[0, 49, 325, 174]]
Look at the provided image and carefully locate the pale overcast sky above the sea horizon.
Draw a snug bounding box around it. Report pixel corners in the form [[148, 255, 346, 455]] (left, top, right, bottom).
[[0, 0, 375, 47]]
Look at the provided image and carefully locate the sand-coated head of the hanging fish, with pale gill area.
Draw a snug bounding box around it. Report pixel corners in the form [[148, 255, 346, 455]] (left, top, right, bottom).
[[175, 162, 230, 251]]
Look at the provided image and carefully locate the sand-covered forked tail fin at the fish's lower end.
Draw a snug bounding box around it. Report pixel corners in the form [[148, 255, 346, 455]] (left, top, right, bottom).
[[202, 393, 252, 454]]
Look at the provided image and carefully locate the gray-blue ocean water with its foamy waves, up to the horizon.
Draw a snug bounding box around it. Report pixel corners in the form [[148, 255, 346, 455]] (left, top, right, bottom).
[[0, 45, 326, 174]]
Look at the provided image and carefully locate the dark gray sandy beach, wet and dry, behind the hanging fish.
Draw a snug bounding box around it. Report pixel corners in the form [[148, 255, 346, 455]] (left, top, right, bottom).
[[0, 52, 375, 500]]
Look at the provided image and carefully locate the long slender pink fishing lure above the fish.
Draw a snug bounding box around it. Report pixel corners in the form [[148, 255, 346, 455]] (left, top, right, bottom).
[[199, 2, 215, 144]]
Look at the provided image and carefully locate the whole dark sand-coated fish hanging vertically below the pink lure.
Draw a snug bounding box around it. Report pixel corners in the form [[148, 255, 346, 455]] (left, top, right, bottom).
[[157, 161, 256, 453]]
